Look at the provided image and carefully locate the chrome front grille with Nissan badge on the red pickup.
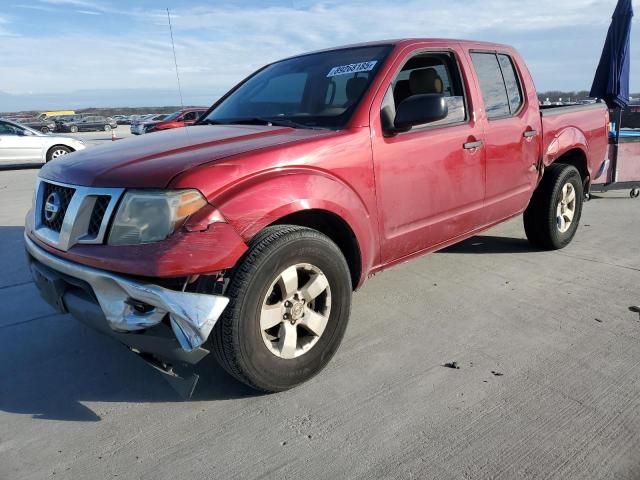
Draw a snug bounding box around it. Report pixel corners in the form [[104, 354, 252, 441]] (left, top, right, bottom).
[[34, 179, 124, 251]]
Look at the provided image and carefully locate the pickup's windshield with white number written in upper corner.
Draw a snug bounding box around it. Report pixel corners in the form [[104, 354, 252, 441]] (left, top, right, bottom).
[[199, 45, 391, 129]]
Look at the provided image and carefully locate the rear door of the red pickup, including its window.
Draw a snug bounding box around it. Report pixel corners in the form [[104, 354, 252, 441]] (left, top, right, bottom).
[[470, 51, 541, 223]]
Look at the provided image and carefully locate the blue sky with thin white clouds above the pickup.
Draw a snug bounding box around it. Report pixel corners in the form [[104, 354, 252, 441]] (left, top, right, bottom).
[[0, 0, 640, 111]]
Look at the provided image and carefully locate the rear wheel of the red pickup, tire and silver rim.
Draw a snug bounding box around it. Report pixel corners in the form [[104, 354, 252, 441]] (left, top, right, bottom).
[[523, 163, 584, 250]]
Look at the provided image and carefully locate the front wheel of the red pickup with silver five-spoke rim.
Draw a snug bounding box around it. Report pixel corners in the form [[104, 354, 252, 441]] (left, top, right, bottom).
[[210, 225, 352, 392]]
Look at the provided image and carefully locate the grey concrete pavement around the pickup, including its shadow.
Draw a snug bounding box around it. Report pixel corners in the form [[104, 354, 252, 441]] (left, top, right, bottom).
[[0, 141, 640, 480]]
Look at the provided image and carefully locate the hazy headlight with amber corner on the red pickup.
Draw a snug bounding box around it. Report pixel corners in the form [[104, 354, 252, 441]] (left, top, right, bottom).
[[109, 190, 207, 245]]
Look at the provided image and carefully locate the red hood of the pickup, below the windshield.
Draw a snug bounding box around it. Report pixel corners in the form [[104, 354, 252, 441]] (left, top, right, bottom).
[[40, 125, 334, 188]]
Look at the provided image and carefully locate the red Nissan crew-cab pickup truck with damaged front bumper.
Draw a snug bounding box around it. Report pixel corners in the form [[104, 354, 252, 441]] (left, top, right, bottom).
[[25, 39, 609, 391]]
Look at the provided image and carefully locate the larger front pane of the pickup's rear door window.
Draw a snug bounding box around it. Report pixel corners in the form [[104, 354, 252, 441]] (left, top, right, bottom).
[[471, 53, 511, 119]]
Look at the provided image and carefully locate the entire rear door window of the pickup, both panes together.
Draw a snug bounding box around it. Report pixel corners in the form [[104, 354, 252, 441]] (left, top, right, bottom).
[[471, 52, 523, 120]]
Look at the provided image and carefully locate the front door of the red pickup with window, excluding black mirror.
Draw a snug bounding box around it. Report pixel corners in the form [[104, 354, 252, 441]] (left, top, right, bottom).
[[371, 50, 485, 263]]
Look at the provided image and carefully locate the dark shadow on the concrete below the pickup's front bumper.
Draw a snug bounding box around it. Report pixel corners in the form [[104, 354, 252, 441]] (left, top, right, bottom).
[[0, 227, 255, 422]]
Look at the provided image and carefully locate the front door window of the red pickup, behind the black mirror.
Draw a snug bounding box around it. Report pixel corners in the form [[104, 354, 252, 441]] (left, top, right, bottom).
[[381, 53, 467, 128]]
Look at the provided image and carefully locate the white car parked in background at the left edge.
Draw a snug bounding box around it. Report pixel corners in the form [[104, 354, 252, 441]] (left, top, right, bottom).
[[0, 119, 86, 165]]
